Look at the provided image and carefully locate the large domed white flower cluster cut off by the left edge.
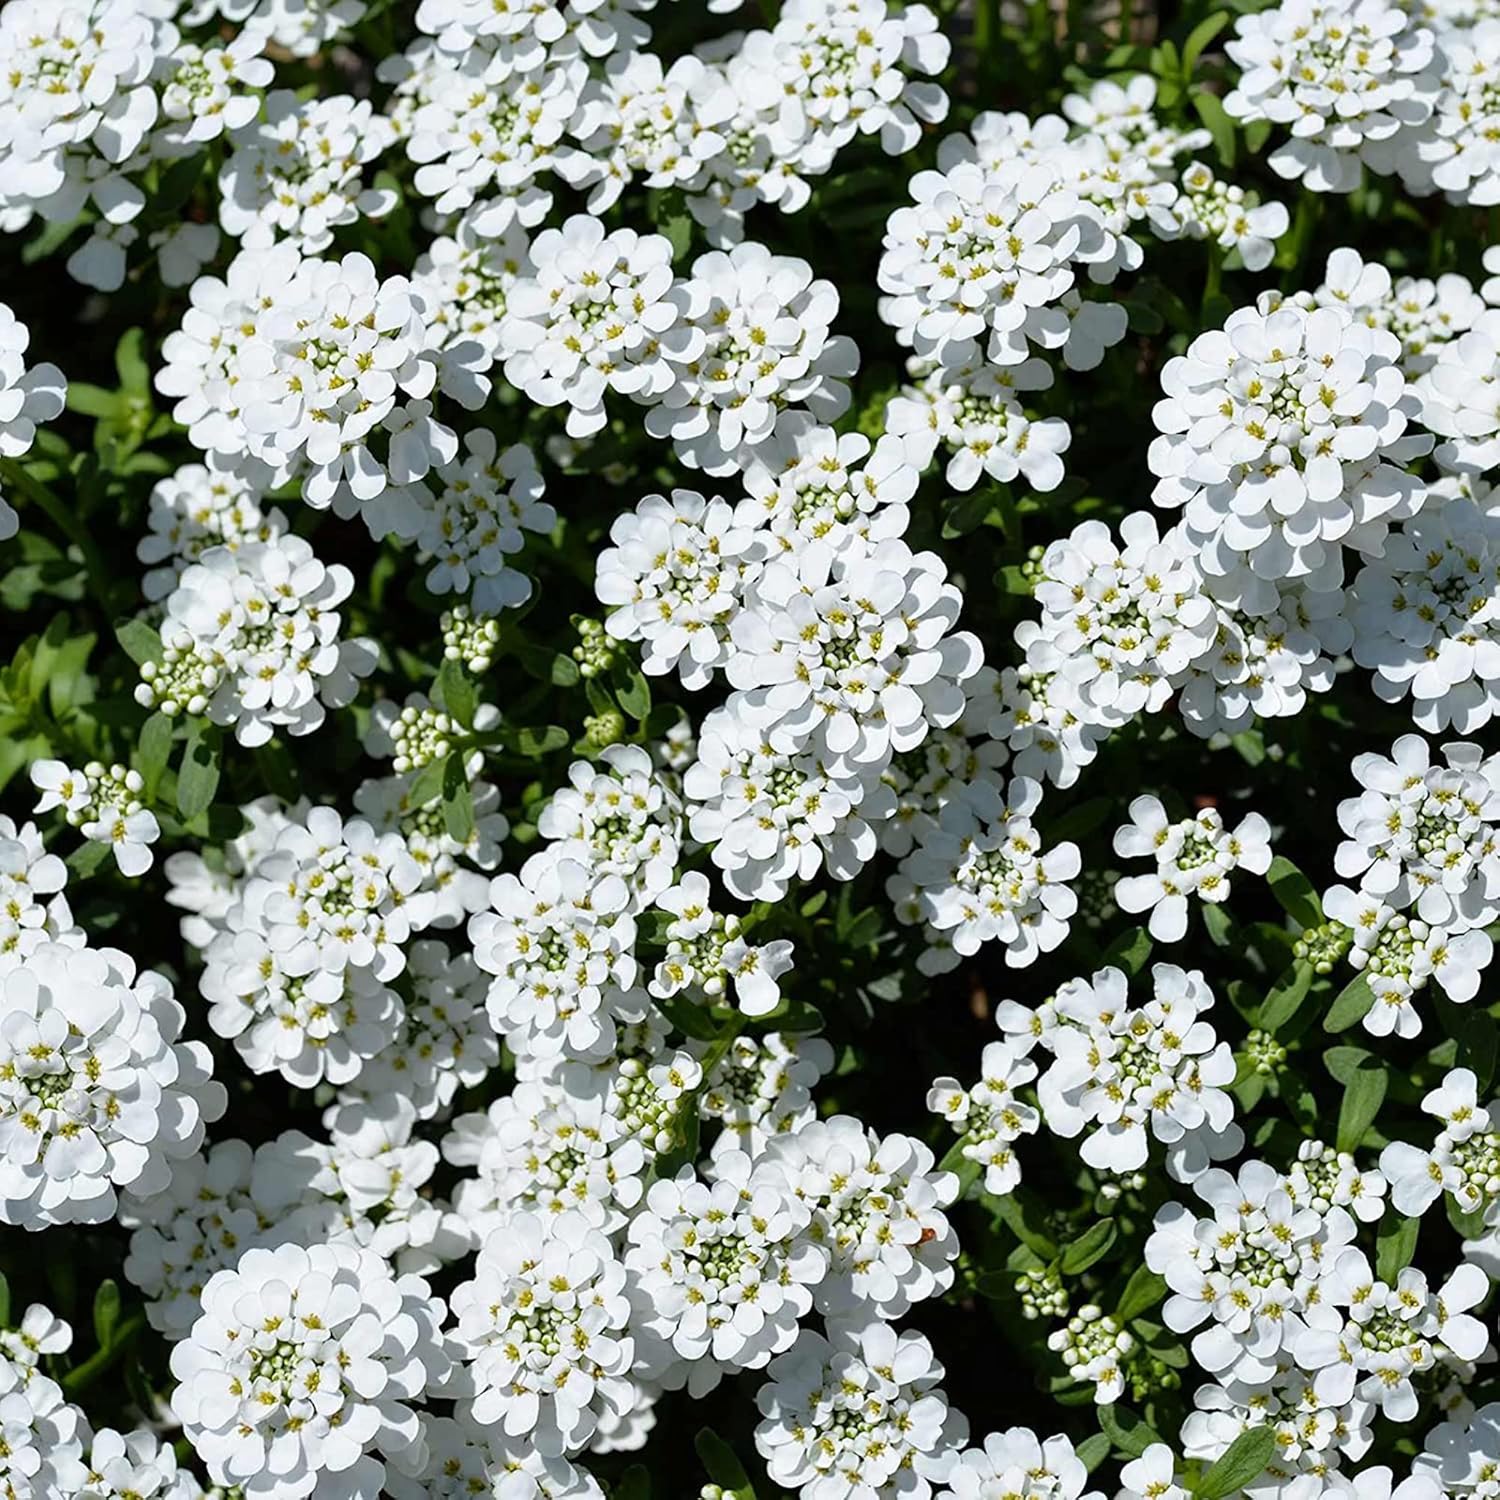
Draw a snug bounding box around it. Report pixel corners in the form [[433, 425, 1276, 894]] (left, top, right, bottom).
[[0, 944, 227, 1229]]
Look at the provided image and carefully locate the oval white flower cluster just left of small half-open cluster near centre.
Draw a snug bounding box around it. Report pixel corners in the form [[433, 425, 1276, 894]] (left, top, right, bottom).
[[468, 851, 636, 1058]]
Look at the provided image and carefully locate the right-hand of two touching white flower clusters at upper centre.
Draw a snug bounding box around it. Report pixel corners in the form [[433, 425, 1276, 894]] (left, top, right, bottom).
[[647, 242, 860, 476]]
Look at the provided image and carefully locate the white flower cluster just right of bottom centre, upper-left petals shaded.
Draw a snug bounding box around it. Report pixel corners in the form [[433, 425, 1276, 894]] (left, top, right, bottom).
[[755, 1323, 968, 1500]]
